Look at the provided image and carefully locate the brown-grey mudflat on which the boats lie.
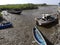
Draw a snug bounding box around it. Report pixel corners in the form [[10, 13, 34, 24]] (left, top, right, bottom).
[[0, 6, 60, 45]]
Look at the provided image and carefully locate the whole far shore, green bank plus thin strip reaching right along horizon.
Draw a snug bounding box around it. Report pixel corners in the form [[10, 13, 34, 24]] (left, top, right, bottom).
[[0, 3, 57, 11]]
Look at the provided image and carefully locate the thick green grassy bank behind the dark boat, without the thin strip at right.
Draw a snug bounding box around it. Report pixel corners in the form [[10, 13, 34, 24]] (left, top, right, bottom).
[[0, 4, 38, 9]]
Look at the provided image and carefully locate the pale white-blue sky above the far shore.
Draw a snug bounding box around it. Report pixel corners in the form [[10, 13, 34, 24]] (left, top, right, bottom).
[[0, 0, 60, 5]]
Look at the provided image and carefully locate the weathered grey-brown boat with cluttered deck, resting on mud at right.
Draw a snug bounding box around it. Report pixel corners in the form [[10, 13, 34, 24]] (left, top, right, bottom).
[[35, 14, 58, 26]]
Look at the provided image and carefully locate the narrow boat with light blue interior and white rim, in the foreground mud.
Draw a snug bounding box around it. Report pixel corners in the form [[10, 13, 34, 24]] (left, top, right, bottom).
[[33, 27, 47, 45]]
